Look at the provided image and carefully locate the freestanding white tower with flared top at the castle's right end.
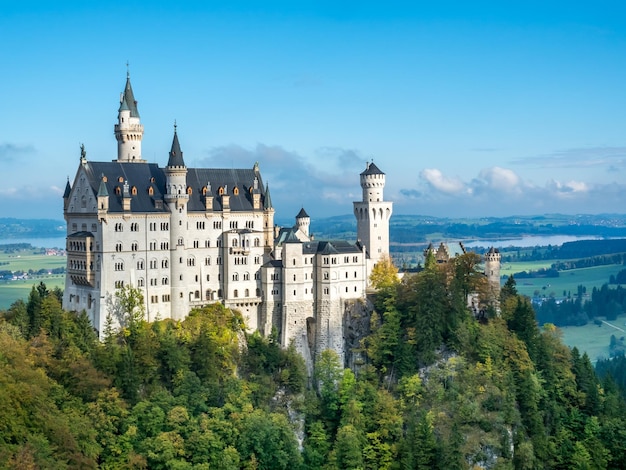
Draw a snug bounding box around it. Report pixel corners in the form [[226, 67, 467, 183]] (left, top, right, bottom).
[[354, 162, 393, 276]]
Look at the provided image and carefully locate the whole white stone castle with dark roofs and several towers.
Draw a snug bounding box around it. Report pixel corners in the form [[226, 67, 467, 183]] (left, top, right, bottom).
[[63, 76, 392, 365]]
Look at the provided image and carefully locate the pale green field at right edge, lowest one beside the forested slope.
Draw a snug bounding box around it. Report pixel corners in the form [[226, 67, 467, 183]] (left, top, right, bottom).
[[559, 314, 626, 362]]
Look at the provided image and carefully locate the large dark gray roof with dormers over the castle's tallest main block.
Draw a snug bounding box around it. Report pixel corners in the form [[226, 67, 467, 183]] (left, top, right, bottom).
[[84, 161, 264, 212]]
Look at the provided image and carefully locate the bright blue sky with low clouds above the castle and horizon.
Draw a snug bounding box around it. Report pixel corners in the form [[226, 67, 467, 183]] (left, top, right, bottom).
[[0, 0, 626, 220]]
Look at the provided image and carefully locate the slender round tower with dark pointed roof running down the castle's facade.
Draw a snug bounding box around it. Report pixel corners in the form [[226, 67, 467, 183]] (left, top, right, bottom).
[[164, 124, 191, 320]]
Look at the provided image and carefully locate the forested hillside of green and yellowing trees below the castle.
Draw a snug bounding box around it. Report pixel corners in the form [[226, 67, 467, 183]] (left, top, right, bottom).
[[0, 253, 626, 470]]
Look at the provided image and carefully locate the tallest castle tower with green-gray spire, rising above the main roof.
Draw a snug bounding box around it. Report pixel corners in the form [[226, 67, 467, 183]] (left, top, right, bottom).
[[115, 72, 145, 163]]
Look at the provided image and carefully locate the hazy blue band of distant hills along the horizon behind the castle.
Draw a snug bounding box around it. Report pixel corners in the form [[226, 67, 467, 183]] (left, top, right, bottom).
[[6, 214, 626, 244]]
